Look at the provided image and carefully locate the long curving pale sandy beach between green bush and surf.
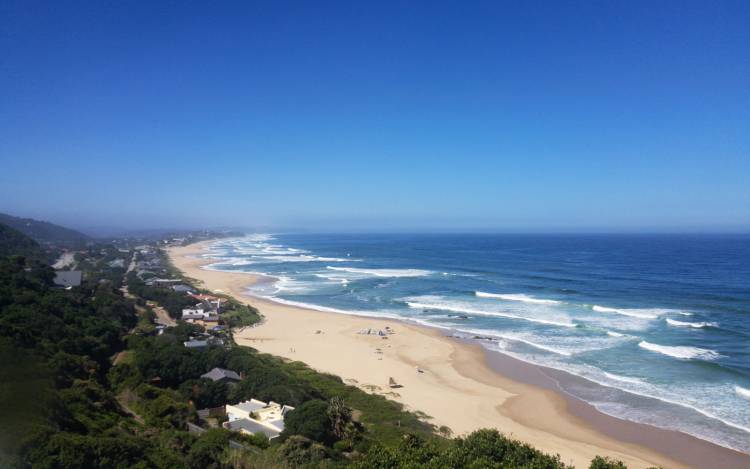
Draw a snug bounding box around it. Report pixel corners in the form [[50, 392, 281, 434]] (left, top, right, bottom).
[[169, 241, 750, 468]]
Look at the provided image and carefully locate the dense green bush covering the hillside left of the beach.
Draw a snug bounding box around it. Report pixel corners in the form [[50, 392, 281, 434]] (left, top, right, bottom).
[[0, 226, 636, 469]]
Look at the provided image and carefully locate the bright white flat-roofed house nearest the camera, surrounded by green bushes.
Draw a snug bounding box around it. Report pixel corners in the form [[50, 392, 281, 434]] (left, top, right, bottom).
[[223, 399, 294, 440]]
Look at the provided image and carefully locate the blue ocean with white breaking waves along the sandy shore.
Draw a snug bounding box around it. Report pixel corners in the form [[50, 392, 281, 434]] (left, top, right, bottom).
[[201, 234, 750, 451]]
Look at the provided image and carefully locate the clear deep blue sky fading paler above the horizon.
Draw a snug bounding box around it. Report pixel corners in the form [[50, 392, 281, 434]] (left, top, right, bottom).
[[0, 0, 750, 231]]
